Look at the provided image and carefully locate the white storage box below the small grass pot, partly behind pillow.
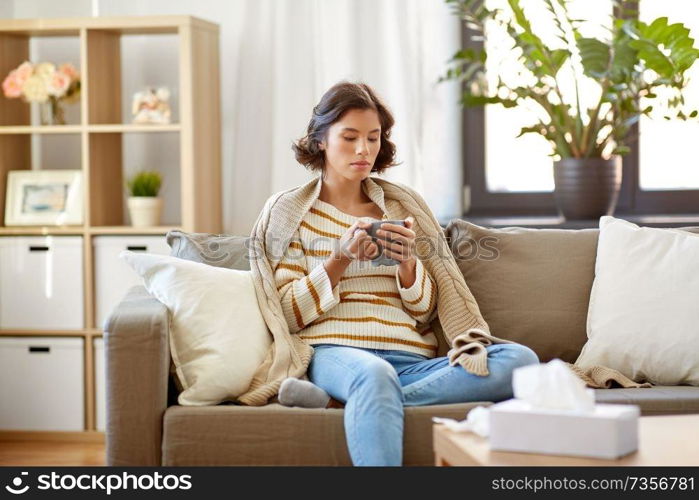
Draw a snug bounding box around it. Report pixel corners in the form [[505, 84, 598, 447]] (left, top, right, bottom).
[[92, 236, 170, 328]]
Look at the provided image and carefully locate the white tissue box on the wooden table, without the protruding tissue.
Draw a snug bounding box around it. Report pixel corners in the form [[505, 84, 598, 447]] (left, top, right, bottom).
[[490, 399, 640, 458]]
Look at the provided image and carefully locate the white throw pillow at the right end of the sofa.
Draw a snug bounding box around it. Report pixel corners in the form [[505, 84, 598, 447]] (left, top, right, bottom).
[[576, 216, 699, 385]]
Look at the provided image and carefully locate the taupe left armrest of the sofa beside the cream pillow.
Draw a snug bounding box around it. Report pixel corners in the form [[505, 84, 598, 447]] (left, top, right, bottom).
[[104, 285, 170, 466]]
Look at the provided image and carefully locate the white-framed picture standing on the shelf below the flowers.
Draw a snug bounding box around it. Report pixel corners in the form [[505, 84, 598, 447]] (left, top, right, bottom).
[[5, 170, 83, 226]]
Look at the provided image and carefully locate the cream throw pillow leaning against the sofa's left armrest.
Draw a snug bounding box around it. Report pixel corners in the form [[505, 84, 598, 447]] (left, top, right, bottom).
[[119, 251, 271, 406]]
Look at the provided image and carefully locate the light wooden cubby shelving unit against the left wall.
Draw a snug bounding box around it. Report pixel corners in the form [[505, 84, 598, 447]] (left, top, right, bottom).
[[0, 16, 222, 439]]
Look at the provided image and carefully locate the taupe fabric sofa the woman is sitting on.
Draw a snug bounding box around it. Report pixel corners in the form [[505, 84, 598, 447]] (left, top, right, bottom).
[[105, 220, 699, 466]]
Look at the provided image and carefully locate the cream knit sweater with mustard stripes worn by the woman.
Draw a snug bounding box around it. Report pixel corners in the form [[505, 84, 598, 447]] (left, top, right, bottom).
[[274, 198, 437, 358]]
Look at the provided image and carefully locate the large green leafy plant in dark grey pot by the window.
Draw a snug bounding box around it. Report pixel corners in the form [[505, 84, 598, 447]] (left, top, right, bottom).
[[440, 0, 699, 219]]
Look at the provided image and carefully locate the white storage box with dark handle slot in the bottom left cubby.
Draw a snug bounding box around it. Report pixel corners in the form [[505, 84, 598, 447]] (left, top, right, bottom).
[[0, 337, 84, 431]]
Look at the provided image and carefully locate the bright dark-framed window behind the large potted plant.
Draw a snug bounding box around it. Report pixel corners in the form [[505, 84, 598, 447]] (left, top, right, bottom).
[[463, 0, 699, 215]]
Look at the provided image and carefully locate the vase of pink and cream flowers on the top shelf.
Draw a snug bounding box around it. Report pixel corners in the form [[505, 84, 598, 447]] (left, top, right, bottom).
[[2, 61, 80, 125]]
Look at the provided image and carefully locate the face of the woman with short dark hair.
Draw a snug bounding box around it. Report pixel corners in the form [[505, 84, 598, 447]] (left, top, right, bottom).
[[321, 109, 381, 181]]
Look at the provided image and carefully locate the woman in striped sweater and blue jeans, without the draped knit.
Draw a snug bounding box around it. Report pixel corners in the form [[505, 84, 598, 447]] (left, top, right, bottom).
[[274, 82, 538, 465]]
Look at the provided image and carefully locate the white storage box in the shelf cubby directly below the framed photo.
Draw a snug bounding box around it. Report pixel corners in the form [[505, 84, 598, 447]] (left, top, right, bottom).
[[0, 236, 85, 330]]
